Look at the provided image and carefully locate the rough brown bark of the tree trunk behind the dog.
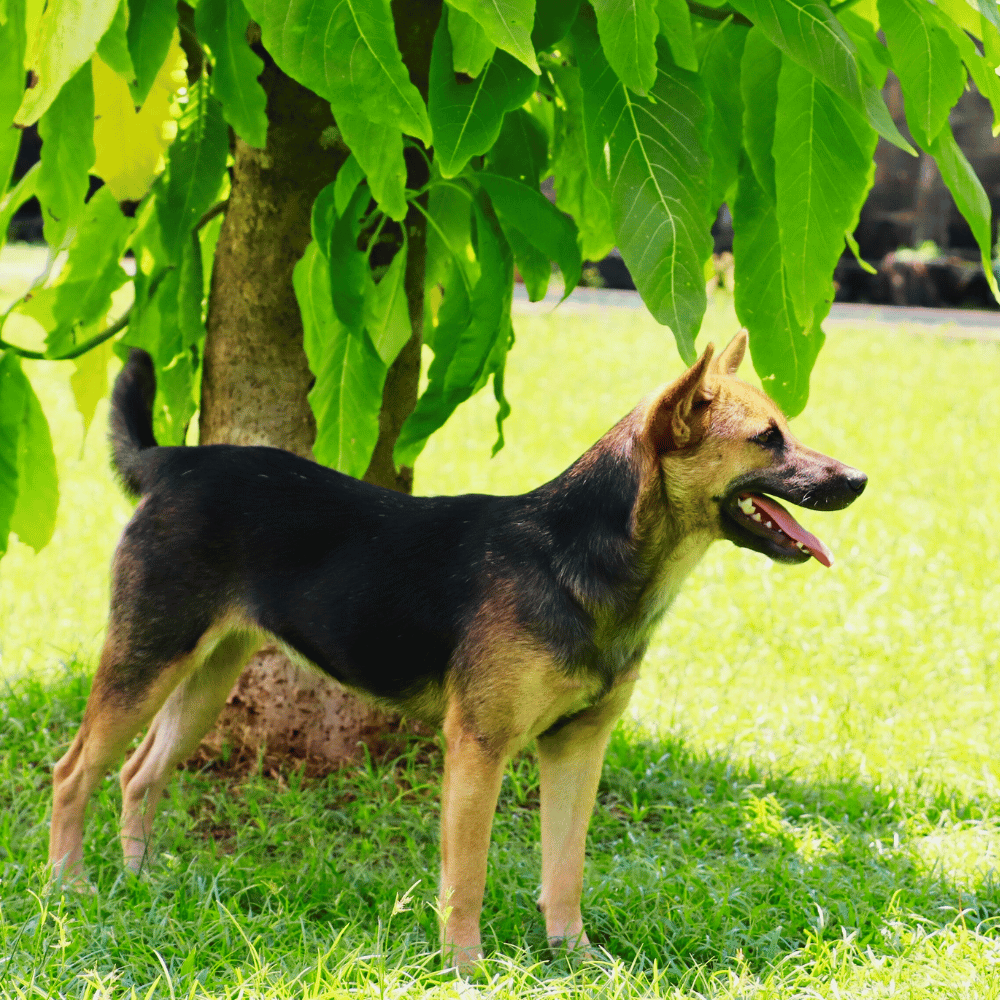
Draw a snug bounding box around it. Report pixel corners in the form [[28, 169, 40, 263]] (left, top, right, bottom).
[[200, 0, 440, 769]]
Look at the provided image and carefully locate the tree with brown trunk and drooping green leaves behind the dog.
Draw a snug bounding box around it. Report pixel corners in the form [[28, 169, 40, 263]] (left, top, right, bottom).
[[0, 0, 1000, 756]]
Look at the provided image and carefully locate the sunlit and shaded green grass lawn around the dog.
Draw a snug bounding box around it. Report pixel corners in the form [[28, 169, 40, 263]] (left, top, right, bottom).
[[0, 268, 1000, 1000]]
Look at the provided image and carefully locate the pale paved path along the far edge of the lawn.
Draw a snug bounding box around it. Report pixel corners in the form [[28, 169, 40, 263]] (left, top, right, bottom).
[[514, 285, 1000, 343]]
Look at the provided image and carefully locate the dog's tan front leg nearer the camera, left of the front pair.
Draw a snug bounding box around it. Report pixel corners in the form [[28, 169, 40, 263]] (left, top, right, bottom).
[[440, 705, 507, 970]]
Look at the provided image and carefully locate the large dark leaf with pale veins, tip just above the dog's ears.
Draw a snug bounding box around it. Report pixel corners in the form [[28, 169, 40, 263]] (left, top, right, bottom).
[[577, 27, 712, 363]]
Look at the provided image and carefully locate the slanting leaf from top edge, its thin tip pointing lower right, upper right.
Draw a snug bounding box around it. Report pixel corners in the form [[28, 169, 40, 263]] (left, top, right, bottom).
[[733, 0, 915, 153]]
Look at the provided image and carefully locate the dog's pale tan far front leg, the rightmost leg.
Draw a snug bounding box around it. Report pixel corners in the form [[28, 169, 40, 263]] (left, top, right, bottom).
[[537, 679, 635, 951]]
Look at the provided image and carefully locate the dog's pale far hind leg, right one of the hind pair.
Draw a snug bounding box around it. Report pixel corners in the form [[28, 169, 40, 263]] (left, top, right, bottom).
[[121, 631, 261, 872]]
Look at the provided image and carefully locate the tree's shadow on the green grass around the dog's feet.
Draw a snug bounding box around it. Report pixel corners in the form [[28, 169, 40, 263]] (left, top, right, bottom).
[[0, 669, 1000, 988]]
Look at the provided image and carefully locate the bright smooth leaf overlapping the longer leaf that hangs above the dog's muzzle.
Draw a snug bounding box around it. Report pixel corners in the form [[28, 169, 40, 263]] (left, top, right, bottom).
[[774, 59, 876, 326]]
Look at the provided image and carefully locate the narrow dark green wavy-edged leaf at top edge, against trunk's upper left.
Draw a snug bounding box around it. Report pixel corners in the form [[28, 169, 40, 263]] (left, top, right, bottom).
[[194, 0, 267, 149]]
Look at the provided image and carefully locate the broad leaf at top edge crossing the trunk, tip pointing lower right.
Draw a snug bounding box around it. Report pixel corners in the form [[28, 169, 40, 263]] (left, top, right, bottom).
[[247, 0, 431, 146]]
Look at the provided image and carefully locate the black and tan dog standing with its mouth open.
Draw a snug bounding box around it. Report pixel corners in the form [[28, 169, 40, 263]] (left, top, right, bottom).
[[49, 333, 866, 965]]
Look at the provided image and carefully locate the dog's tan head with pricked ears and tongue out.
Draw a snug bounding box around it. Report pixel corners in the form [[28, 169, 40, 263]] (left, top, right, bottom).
[[641, 330, 868, 566]]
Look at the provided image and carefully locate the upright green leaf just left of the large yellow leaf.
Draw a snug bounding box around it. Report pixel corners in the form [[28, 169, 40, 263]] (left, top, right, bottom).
[[36, 62, 97, 250]]
